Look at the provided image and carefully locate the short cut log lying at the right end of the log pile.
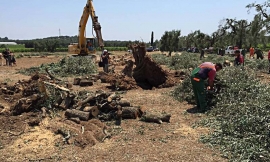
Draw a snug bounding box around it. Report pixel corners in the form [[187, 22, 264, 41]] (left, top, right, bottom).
[[141, 112, 171, 124]]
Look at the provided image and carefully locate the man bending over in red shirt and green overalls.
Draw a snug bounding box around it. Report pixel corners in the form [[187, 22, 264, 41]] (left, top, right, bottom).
[[191, 62, 222, 112]]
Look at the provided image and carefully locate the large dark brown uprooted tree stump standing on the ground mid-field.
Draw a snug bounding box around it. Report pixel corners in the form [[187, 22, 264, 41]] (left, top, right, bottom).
[[130, 43, 174, 89]]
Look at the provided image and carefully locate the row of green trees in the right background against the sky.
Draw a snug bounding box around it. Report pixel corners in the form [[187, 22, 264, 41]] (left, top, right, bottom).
[[160, 1, 270, 54]]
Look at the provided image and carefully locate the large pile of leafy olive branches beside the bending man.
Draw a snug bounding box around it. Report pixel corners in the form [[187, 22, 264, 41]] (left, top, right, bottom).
[[172, 52, 270, 161]]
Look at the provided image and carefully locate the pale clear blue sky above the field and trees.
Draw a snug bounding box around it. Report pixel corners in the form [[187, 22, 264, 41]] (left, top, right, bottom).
[[0, 0, 265, 42]]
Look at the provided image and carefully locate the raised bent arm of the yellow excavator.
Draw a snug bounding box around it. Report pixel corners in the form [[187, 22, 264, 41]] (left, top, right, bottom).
[[78, 0, 104, 55]]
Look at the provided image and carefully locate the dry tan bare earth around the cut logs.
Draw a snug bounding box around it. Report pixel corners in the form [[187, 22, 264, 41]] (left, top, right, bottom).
[[0, 56, 227, 162]]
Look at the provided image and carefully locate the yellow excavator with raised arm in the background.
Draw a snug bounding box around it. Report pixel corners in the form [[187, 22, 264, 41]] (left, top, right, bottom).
[[68, 0, 104, 56]]
